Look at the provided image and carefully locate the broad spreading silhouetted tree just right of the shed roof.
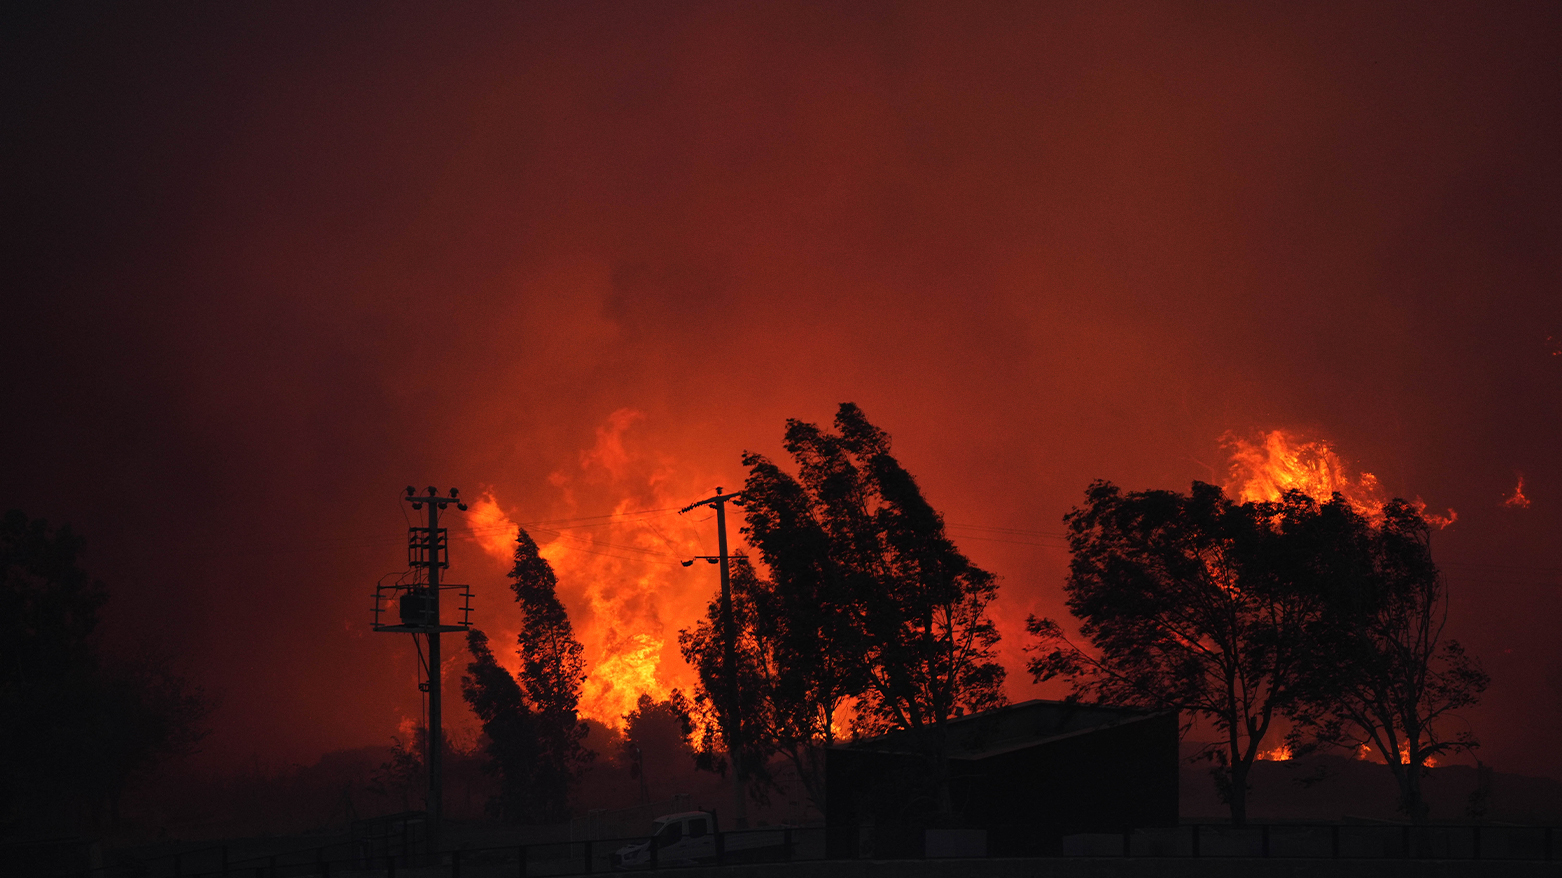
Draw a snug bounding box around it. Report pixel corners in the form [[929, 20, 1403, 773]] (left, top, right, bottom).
[[1028, 481, 1321, 823]]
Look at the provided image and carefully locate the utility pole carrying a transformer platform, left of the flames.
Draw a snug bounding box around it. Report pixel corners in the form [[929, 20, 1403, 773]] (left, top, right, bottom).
[[375, 487, 472, 851]]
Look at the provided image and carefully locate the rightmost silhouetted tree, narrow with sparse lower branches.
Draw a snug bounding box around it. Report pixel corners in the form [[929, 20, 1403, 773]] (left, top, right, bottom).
[[1298, 500, 1490, 823]]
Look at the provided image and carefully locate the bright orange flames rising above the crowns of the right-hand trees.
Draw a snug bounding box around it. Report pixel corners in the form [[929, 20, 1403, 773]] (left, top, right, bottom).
[[1221, 430, 1459, 528]]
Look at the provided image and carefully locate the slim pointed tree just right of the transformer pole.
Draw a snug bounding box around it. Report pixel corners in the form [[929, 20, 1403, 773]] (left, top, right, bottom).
[[462, 530, 592, 823]]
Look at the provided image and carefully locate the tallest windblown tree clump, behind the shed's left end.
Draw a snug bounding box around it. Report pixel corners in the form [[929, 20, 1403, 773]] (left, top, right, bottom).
[[681, 403, 1004, 806]]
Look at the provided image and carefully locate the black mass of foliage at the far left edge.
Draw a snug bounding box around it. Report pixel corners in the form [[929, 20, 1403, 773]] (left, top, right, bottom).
[[0, 511, 212, 834]]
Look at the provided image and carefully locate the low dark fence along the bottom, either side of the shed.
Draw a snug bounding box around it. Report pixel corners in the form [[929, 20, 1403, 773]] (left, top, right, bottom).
[[9, 823, 1562, 878]]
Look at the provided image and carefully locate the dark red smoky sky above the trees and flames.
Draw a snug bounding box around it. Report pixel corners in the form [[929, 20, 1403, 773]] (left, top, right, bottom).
[[0, 3, 1562, 775]]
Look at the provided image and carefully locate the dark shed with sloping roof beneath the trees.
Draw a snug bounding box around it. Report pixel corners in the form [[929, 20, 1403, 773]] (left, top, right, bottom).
[[825, 701, 1178, 858]]
